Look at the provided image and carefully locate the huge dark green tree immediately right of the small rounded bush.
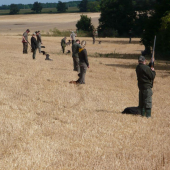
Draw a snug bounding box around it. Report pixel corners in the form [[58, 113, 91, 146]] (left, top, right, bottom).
[[99, 0, 136, 36]]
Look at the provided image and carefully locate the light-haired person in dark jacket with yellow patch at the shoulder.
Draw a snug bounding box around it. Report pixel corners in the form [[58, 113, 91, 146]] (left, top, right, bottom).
[[76, 40, 89, 84]]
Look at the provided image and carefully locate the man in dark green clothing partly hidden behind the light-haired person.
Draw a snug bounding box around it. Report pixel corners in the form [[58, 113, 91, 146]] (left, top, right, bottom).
[[72, 40, 81, 73]]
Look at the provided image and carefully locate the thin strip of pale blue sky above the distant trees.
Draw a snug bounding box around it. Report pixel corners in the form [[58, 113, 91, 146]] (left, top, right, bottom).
[[0, 0, 77, 6]]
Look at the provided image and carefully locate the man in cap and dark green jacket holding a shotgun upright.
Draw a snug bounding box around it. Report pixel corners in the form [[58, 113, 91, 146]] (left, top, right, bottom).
[[136, 56, 156, 118]]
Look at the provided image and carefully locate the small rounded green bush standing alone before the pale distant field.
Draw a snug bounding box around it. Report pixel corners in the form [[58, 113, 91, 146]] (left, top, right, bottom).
[[76, 15, 94, 31]]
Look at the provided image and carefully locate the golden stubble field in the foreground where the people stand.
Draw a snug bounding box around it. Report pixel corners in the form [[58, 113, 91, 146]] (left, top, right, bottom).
[[0, 15, 170, 170]]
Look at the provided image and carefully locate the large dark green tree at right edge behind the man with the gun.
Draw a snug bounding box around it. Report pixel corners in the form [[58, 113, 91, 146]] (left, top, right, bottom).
[[141, 0, 170, 55]]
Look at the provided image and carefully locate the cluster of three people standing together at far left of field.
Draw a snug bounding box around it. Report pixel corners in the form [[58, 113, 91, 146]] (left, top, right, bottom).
[[22, 29, 42, 59]]
